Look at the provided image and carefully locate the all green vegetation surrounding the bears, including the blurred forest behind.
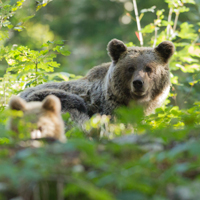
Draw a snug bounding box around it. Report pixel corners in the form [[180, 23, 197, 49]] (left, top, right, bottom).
[[0, 0, 200, 200]]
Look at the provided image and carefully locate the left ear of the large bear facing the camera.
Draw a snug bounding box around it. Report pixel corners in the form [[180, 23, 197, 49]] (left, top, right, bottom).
[[107, 39, 127, 62]]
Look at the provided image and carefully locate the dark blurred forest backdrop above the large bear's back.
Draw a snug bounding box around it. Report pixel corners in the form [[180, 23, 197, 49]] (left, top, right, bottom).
[[0, 0, 200, 75]]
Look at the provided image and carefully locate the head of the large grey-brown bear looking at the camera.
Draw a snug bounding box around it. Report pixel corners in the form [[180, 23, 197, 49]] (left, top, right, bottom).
[[107, 39, 174, 111]]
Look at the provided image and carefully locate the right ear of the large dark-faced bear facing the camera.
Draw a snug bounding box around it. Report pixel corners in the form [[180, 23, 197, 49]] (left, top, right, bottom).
[[155, 41, 175, 62]]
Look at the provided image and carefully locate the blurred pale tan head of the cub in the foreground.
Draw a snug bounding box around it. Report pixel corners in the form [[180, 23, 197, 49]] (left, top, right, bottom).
[[9, 95, 66, 142]]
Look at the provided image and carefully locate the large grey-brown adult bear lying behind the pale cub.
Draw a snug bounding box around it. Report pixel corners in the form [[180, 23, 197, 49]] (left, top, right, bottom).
[[20, 39, 174, 117]]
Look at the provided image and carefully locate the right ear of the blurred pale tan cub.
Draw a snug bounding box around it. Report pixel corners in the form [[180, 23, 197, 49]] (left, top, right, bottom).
[[42, 95, 61, 114]]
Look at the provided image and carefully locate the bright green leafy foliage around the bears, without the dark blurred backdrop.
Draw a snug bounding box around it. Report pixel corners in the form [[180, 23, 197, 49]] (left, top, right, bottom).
[[0, 0, 200, 200]]
